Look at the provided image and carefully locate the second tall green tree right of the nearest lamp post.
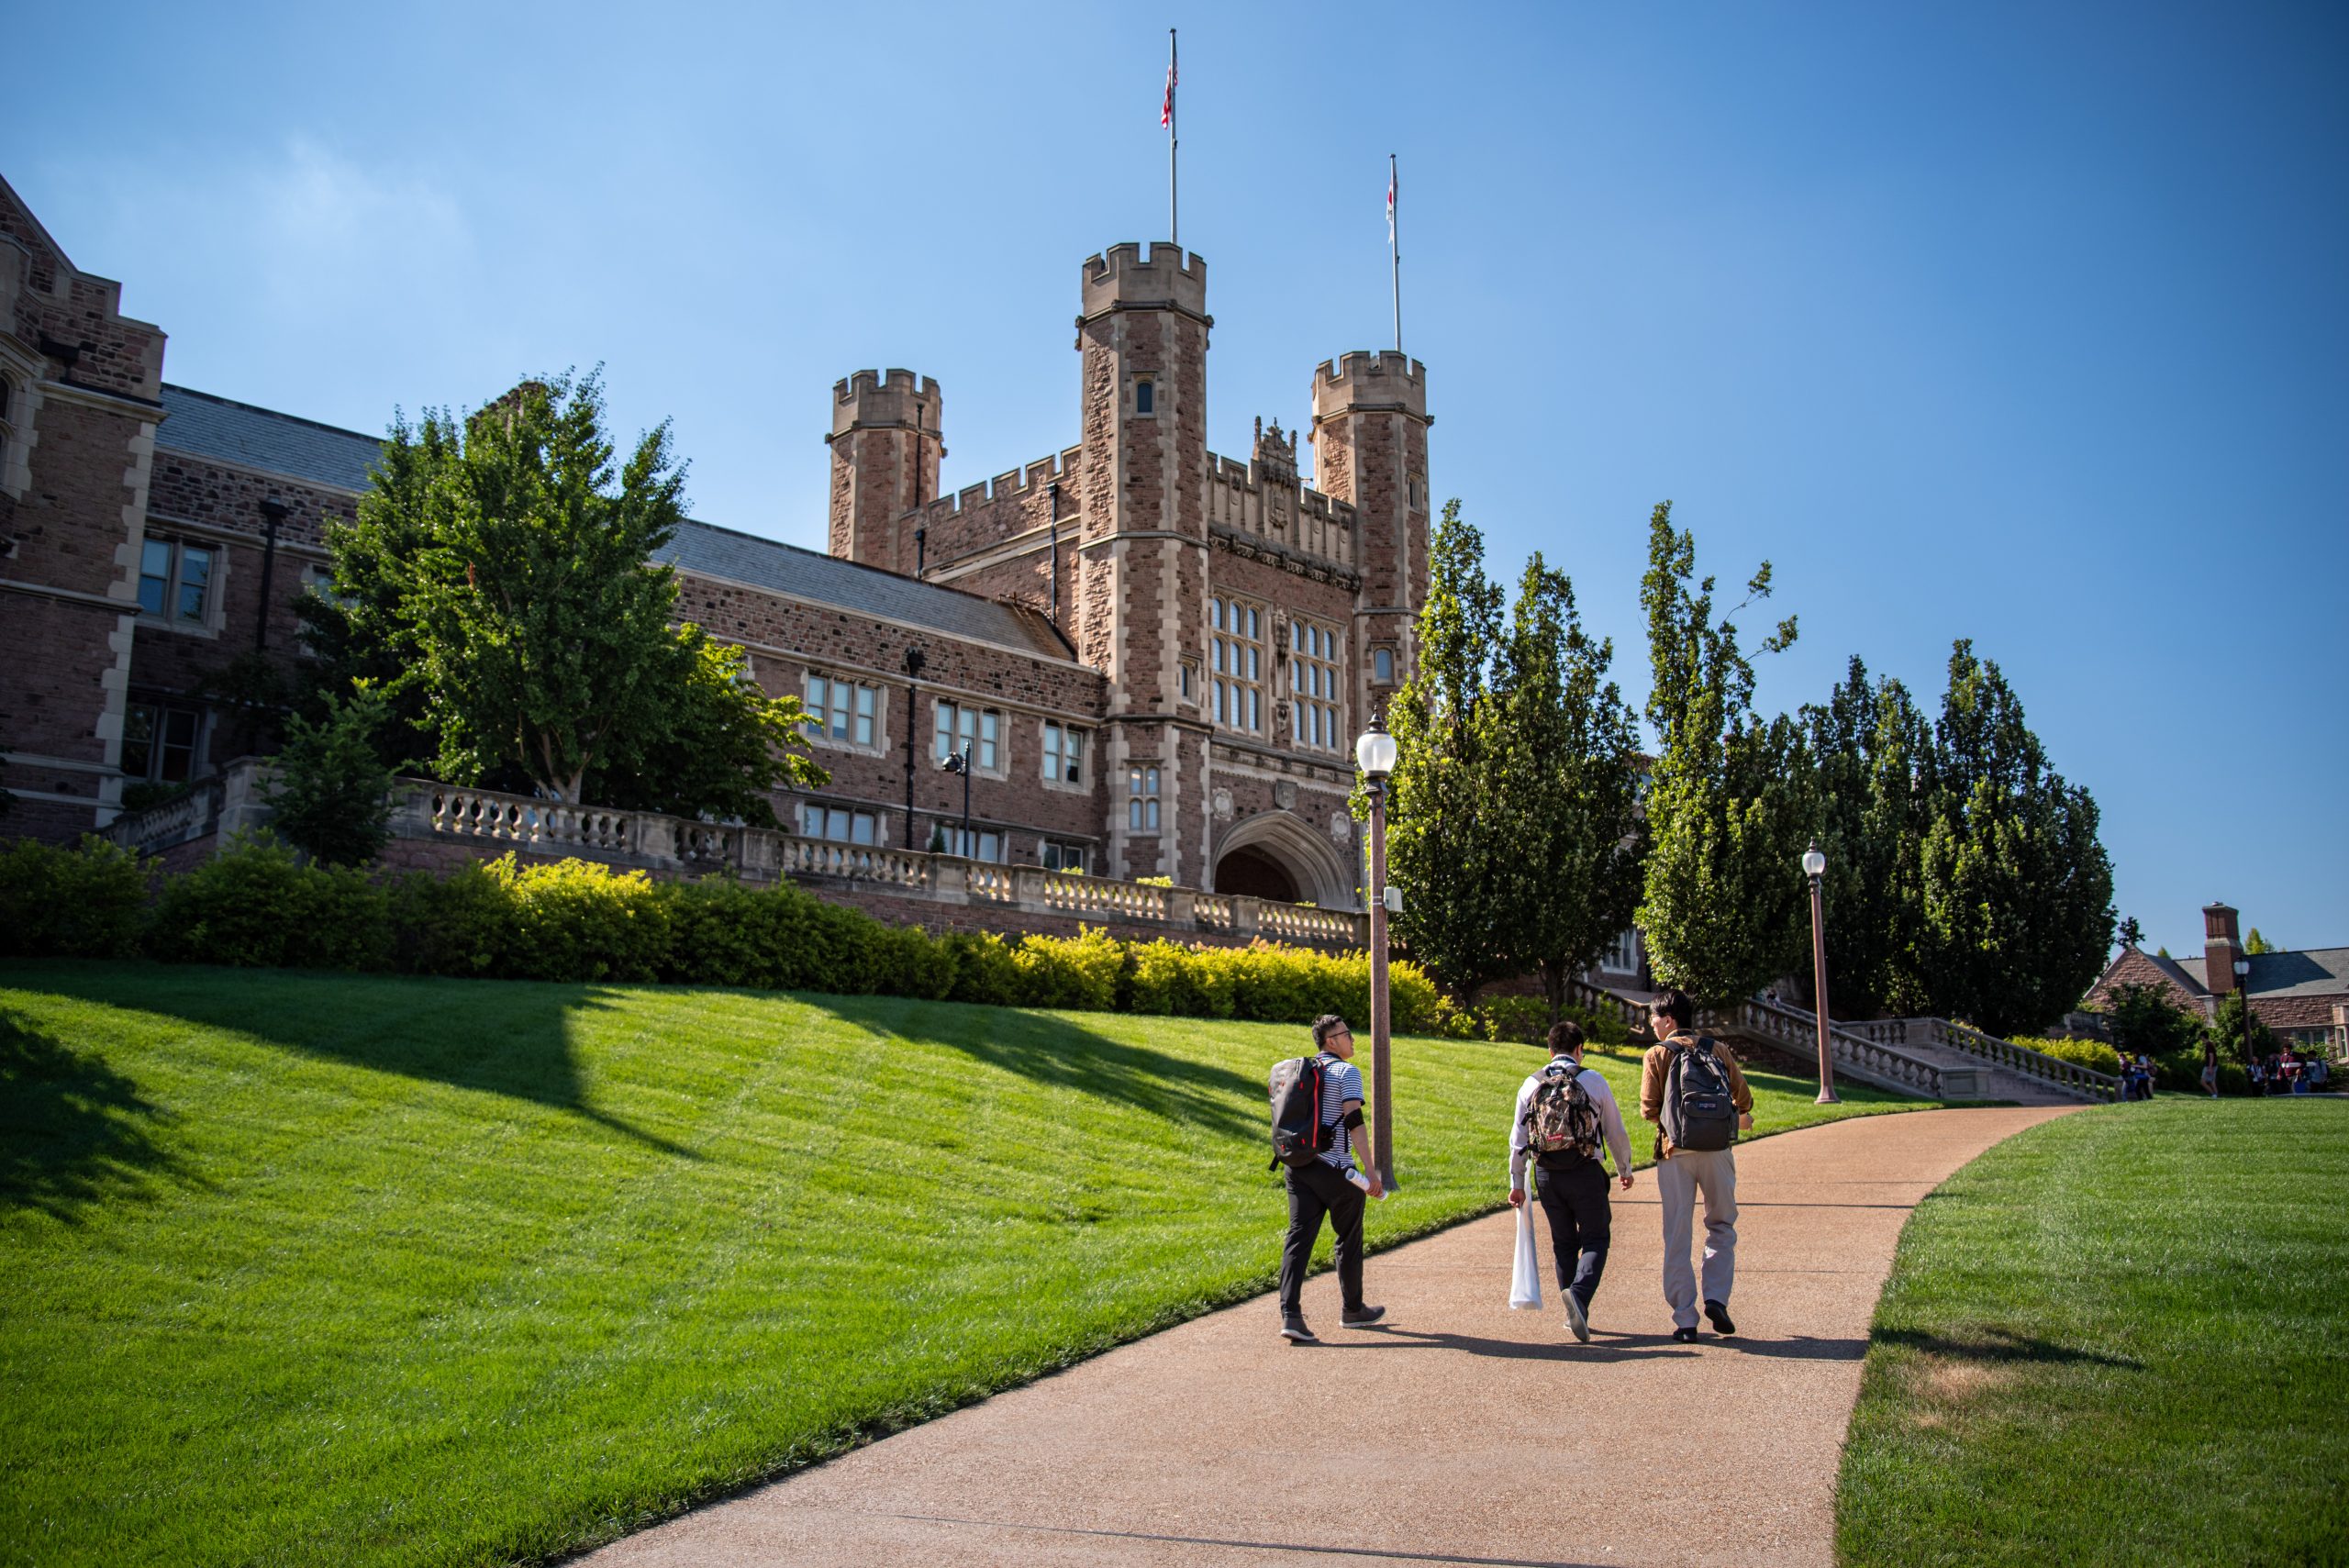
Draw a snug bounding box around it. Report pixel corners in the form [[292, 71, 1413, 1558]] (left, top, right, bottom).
[[1489, 554, 1647, 1021]]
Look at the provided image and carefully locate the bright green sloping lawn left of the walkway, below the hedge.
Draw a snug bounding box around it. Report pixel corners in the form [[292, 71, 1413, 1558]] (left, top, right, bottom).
[[0, 964, 1908, 1565]]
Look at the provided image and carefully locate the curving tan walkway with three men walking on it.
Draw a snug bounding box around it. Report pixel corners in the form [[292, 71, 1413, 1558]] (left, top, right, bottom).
[[584, 1106, 2065, 1568]]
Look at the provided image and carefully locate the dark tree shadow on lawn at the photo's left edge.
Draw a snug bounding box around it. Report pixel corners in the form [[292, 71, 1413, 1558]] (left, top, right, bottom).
[[0, 1009, 202, 1225]]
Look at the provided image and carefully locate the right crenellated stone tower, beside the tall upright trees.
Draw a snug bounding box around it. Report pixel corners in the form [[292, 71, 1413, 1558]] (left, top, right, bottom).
[[1313, 350, 1435, 716]]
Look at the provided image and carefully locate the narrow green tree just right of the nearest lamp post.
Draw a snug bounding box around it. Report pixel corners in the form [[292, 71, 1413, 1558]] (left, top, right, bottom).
[[1355, 500, 1508, 997]]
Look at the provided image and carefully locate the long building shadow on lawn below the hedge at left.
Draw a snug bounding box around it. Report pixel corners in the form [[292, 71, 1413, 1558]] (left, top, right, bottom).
[[11, 964, 700, 1160]]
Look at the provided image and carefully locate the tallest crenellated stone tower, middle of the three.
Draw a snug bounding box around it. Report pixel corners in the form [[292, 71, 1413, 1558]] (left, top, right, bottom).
[[1071, 244, 1215, 885]]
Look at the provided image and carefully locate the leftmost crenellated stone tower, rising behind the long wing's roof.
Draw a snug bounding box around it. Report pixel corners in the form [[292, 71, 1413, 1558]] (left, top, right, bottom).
[[825, 371, 947, 573]]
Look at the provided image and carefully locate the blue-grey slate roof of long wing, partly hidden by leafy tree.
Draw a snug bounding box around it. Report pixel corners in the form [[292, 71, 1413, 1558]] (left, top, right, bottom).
[[141, 385, 1074, 660]]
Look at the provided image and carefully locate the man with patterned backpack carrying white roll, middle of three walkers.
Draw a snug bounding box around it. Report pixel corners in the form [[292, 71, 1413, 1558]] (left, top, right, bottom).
[[1508, 1023, 1631, 1342]]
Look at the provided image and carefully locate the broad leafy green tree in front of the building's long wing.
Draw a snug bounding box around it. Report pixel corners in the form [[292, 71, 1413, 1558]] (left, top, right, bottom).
[[307, 375, 825, 824]]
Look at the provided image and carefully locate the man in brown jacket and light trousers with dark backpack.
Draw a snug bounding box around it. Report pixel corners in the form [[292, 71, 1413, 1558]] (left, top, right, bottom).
[[1640, 991, 1754, 1345]]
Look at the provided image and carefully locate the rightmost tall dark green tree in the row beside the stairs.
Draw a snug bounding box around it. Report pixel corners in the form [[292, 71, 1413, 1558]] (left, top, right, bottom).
[[1920, 640, 2114, 1035]]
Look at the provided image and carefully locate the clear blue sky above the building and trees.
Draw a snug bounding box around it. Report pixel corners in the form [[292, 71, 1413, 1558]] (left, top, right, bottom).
[[0, 0, 2349, 953]]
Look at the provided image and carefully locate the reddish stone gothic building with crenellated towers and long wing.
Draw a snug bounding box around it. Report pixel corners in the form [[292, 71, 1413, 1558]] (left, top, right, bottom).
[[0, 185, 1431, 906]]
